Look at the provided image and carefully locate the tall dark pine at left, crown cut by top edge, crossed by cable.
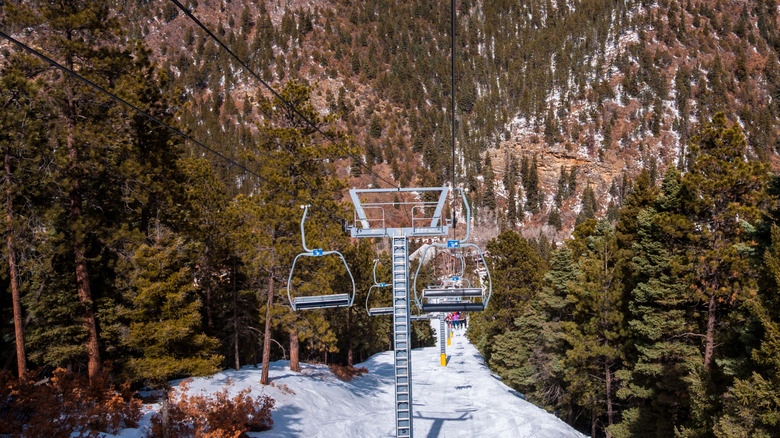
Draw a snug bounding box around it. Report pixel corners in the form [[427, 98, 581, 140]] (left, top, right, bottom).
[[17, 0, 138, 381]]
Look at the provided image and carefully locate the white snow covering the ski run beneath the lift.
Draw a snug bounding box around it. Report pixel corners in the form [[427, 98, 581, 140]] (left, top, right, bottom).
[[116, 319, 584, 438]]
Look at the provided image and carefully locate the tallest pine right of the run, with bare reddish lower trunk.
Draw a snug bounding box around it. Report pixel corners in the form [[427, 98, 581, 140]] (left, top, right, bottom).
[[682, 113, 768, 369]]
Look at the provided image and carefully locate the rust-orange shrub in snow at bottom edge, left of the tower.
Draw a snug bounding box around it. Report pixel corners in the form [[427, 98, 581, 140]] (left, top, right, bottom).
[[151, 382, 274, 438]]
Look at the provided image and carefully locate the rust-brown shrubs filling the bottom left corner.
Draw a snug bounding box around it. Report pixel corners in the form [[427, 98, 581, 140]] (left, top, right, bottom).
[[0, 368, 141, 437]]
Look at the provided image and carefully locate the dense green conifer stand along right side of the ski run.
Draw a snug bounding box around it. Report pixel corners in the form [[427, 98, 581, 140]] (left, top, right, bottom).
[[469, 113, 780, 437]]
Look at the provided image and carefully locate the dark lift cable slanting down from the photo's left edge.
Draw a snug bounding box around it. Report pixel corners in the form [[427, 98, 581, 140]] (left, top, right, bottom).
[[0, 30, 346, 224]]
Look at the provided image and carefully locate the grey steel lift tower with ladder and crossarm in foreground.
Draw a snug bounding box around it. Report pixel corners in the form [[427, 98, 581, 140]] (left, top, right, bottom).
[[347, 187, 450, 438]]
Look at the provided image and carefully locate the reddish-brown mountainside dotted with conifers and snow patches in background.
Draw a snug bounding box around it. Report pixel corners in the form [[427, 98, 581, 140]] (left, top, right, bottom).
[[108, 0, 780, 240]]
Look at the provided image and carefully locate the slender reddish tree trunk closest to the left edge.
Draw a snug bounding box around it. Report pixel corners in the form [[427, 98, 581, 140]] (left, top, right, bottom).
[[4, 148, 27, 382]]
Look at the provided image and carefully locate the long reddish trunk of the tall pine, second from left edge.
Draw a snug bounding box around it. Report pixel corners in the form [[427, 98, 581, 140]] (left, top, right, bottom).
[[67, 98, 100, 383]]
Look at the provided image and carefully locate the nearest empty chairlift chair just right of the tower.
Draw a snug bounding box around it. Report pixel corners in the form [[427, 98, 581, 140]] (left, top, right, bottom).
[[413, 190, 493, 312]]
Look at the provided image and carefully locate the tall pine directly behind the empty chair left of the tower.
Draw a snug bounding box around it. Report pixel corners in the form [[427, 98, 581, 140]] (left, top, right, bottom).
[[251, 82, 348, 384]]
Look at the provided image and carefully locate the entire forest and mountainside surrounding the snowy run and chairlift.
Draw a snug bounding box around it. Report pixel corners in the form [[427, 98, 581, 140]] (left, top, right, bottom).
[[0, 0, 780, 438]]
